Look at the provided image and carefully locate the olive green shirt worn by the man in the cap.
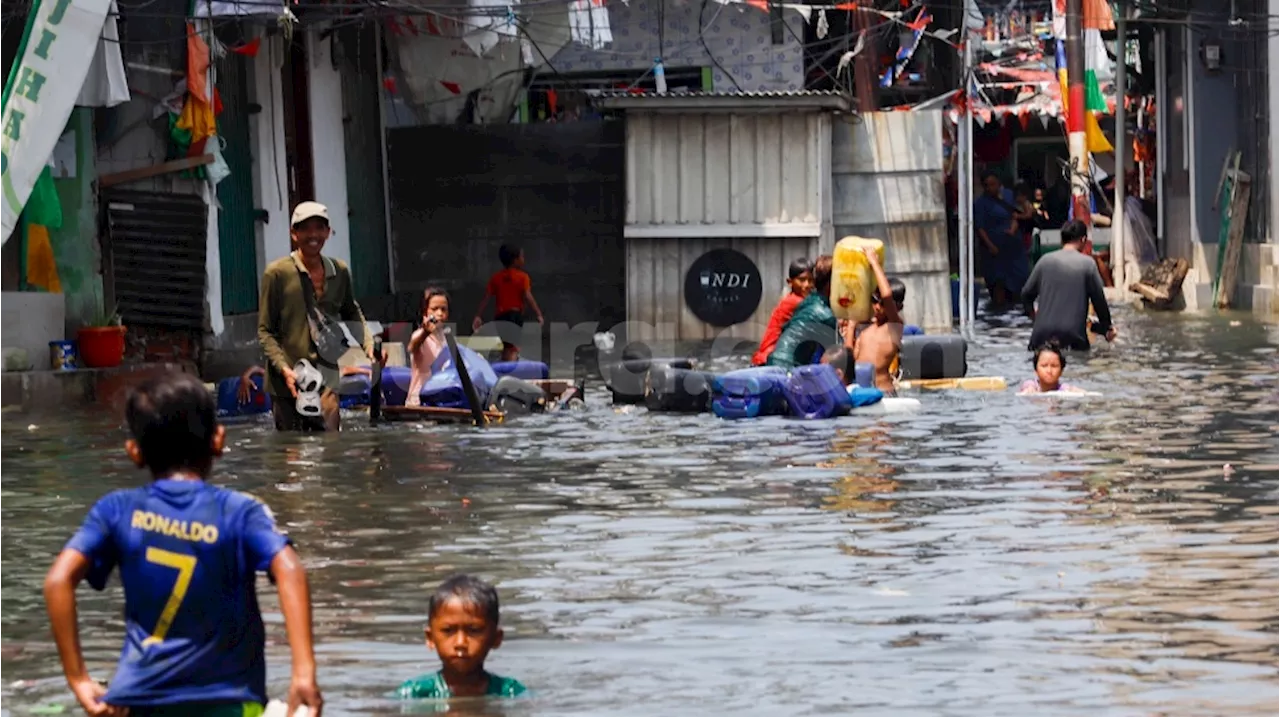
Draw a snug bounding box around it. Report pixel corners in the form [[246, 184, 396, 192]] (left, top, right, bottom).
[[257, 252, 374, 398]]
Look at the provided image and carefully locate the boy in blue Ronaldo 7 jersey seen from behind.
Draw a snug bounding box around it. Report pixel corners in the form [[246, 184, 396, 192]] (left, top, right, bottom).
[[45, 374, 321, 717]]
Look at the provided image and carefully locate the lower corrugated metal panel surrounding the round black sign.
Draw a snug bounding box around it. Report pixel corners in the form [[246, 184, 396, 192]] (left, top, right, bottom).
[[627, 237, 818, 342]]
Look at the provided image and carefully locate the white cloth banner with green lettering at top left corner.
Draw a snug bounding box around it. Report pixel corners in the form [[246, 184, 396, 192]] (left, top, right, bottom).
[[0, 0, 111, 246]]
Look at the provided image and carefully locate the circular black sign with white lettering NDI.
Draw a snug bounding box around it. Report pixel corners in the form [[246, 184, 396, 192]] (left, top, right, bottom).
[[685, 248, 763, 326]]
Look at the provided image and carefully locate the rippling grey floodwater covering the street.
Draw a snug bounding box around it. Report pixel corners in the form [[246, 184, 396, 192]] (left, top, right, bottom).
[[0, 311, 1280, 717]]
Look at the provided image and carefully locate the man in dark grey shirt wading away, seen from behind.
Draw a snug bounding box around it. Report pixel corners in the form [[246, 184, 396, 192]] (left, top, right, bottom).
[[1023, 220, 1116, 351]]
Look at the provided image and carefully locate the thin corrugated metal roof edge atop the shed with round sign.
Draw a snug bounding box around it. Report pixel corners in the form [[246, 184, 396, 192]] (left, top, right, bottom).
[[596, 90, 851, 111]]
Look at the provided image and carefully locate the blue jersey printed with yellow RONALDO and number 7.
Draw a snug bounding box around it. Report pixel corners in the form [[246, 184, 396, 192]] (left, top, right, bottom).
[[67, 479, 289, 707]]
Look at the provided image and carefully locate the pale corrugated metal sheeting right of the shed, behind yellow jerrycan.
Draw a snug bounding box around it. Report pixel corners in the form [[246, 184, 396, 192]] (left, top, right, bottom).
[[831, 111, 951, 329]]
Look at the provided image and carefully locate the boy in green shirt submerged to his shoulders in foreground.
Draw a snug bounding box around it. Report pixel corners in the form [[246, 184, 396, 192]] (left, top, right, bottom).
[[397, 575, 527, 699]]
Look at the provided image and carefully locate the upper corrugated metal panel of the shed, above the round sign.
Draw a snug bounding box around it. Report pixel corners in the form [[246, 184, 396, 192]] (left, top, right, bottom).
[[626, 111, 831, 237]]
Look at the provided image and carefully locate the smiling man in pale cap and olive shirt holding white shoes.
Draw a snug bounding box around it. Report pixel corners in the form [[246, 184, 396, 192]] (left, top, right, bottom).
[[257, 201, 374, 430]]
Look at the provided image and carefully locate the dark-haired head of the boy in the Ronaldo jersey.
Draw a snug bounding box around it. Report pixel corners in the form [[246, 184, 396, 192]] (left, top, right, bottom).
[[124, 373, 225, 478]]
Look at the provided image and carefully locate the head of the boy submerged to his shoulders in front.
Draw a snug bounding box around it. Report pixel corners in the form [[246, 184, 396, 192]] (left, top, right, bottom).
[[426, 575, 502, 679]]
